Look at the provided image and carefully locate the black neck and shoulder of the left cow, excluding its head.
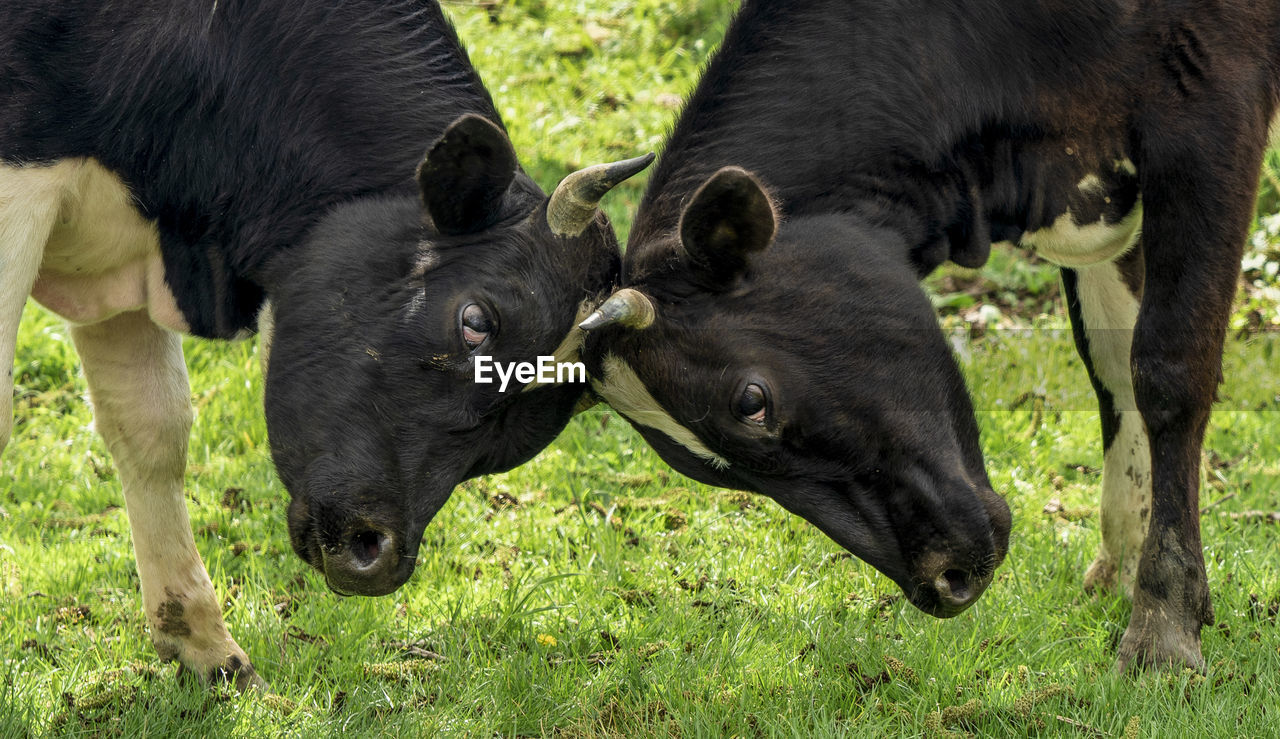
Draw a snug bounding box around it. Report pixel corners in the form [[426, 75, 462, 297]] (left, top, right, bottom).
[[0, 0, 497, 336]]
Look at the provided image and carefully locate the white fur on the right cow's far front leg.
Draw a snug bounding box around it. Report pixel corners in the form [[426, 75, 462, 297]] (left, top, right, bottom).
[[1076, 257, 1151, 597]]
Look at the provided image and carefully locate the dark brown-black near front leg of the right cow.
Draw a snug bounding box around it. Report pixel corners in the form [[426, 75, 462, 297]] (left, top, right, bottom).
[[1117, 112, 1266, 670]]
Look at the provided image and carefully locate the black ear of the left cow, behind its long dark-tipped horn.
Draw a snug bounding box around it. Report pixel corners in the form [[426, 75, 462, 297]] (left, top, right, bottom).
[[417, 113, 518, 234]]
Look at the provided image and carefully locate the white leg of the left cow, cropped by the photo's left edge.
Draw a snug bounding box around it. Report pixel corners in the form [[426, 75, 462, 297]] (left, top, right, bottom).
[[0, 166, 61, 451]]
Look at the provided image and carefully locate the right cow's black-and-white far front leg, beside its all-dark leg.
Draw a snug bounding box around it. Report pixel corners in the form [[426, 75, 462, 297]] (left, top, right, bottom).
[[1062, 247, 1151, 598]]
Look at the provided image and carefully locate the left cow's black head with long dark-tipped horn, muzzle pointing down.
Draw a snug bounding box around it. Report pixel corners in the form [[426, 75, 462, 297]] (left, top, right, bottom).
[[264, 115, 652, 596]]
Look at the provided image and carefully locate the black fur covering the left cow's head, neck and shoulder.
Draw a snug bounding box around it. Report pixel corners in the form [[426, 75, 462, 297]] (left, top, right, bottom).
[[0, 0, 634, 594]]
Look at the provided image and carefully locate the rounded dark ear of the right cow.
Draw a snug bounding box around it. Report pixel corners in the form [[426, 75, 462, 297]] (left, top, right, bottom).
[[680, 166, 778, 286]]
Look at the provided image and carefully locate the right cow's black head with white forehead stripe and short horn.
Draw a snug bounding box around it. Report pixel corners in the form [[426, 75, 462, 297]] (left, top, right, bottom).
[[582, 168, 1010, 616]]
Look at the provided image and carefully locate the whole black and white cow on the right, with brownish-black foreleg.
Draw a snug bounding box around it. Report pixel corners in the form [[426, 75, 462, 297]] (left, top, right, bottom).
[[584, 0, 1280, 669]]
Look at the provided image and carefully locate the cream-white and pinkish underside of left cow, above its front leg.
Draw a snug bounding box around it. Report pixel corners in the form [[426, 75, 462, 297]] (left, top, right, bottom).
[[0, 159, 188, 332]]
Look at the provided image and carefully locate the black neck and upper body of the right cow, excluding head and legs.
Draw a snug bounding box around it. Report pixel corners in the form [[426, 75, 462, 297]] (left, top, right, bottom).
[[625, 0, 1280, 274]]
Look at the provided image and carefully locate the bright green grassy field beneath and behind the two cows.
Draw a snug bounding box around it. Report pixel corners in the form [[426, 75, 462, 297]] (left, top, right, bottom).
[[0, 0, 1280, 736]]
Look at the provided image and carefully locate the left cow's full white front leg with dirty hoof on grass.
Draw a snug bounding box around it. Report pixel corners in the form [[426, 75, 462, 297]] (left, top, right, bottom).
[[72, 311, 261, 690]]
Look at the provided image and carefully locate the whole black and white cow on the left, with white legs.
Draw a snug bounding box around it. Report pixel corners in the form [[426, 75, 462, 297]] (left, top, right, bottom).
[[0, 0, 649, 686]]
